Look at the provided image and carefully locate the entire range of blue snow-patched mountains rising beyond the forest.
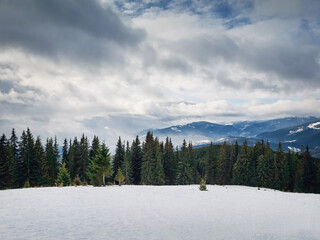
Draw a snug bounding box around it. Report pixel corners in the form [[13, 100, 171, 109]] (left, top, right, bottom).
[[140, 117, 320, 158]]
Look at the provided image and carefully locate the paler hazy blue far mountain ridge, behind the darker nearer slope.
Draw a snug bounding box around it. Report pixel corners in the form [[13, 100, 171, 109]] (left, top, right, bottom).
[[139, 117, 320, 145]]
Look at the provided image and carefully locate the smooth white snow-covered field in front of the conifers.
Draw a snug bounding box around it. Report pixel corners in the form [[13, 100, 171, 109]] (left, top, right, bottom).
[[0, 185, 320, 240]]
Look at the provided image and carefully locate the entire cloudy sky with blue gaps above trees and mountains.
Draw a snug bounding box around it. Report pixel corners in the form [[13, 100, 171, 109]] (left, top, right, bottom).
[[0, 0, 320, 145]]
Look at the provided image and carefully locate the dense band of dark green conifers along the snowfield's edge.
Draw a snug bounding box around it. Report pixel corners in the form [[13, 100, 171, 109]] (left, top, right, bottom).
[[0, 128, 320, 193]]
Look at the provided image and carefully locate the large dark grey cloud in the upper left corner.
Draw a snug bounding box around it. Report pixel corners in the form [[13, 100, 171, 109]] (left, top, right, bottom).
[[0, 0, 145, 62]]
